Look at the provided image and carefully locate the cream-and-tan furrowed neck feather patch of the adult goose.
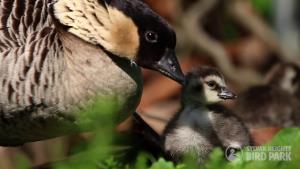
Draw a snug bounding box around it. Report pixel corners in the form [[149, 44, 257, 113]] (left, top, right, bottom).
[[53, 0, 139, 59]]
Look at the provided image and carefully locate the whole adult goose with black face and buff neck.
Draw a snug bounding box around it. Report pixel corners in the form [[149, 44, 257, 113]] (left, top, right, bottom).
[[0, 0, 183, 145]]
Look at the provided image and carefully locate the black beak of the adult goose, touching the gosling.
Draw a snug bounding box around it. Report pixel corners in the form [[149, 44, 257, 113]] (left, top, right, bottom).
[[152, 49, 185, 85]]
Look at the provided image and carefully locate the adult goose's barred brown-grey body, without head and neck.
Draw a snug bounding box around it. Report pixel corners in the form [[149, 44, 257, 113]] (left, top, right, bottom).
[[0, 0, 142, 145]]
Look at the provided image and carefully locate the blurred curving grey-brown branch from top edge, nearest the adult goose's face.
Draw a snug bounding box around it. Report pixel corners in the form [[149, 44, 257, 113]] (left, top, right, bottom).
[[183, 0, 262, 87]]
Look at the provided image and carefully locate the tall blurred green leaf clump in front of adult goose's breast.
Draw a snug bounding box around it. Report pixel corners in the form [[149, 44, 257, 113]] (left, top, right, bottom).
[[55, 98, 120, 169]]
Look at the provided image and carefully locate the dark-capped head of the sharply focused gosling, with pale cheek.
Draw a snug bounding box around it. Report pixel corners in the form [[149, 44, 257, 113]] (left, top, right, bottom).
[[183, 67, 236, 104]]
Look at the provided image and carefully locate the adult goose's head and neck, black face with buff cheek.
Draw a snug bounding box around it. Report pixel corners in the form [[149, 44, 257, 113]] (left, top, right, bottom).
[[50, 0, 185, 83]]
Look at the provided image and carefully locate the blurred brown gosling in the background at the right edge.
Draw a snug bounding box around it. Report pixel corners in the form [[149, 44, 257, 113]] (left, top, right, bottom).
[[234, 63, 300, 129]]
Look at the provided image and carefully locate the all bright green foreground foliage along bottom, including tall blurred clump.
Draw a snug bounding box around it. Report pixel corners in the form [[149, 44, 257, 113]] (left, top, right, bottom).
[[18, 95, 300, 169]]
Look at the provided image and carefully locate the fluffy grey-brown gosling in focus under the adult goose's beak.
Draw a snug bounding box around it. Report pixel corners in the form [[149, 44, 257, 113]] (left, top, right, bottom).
[[161, 67, 250, 163]]
